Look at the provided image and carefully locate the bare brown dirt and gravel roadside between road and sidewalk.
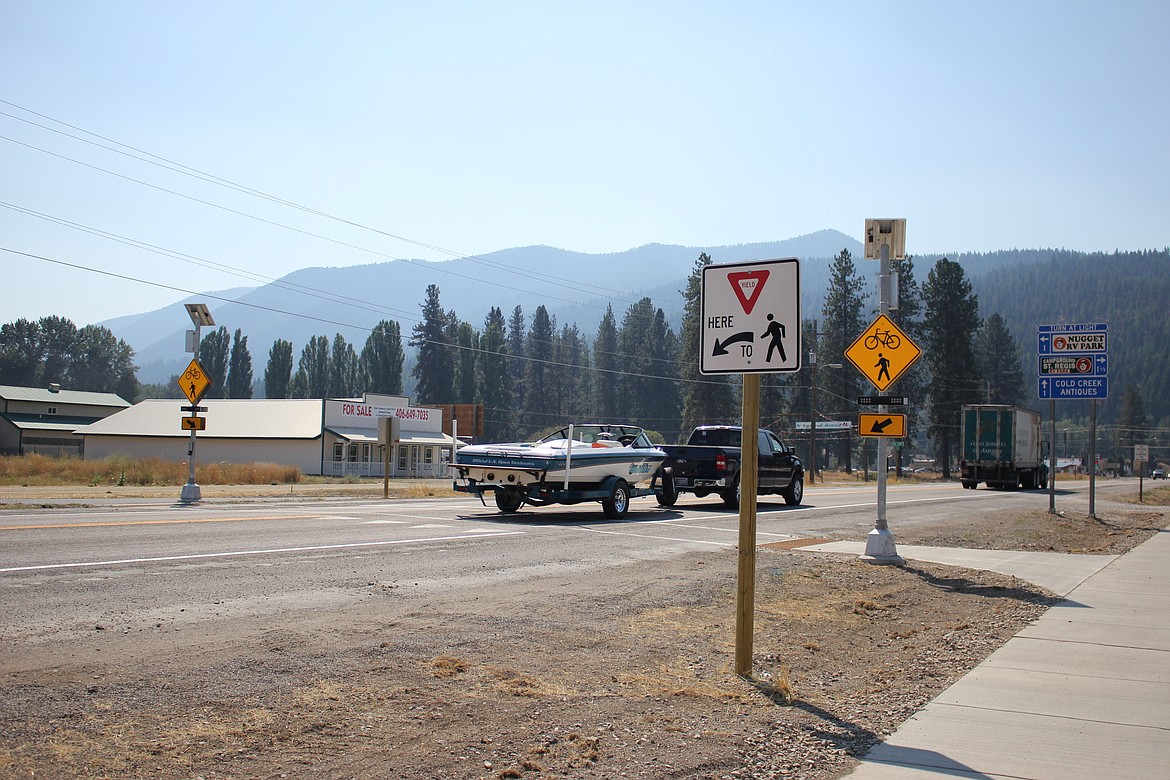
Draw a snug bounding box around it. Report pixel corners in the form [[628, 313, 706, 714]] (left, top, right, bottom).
[[0, 484, 1170, 780]]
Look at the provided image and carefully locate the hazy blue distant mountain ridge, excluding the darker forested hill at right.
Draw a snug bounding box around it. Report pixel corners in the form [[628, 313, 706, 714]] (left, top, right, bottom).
[[109, 230, 862, 384]]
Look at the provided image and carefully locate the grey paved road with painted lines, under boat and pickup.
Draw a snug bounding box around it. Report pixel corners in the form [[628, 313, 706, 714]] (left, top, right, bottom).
[[0, 483, 1109, 647]]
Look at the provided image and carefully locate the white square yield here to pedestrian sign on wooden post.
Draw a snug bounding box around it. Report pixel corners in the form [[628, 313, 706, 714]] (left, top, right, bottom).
[[698, 258, 803, 374]]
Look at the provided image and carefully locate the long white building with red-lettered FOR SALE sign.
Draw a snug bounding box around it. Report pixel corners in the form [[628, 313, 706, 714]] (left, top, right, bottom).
[[76, 393, 453, 477]]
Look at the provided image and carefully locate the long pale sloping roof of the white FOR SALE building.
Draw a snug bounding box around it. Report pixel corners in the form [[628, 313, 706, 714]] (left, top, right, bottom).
[[77, 399, 325, 439]]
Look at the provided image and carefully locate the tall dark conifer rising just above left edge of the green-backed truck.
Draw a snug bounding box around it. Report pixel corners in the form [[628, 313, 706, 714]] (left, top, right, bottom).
[[922, 257, 980, 479]]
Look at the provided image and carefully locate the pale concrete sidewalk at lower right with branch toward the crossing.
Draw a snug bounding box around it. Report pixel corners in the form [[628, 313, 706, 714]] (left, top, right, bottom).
[[806, 529, 1170, 780]]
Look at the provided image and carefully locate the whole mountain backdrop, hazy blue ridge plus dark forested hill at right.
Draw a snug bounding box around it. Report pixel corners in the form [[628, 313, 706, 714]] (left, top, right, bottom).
[[101, 230, 1170, 430]]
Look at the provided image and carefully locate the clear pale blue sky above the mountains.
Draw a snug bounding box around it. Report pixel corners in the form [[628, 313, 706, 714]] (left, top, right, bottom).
[[0, 0, 1170, 326]]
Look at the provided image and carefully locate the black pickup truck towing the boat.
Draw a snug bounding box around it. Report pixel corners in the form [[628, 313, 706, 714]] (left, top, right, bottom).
[[659, 426, 804, 509]]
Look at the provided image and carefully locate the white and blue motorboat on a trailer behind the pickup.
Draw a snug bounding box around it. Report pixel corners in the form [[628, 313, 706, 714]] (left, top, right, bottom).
[[450, 423, 674, 518]]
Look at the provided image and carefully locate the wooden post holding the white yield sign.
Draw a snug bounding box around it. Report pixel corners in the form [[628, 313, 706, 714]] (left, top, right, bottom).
[[735, 374, 759, 677]]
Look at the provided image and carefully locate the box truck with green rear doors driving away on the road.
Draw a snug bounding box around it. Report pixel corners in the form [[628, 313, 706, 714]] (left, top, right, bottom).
[[959, 403, 1048, 490]]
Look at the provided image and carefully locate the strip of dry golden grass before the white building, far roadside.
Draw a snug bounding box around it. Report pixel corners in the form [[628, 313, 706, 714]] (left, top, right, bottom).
[[0, 455, 302, 488]]
